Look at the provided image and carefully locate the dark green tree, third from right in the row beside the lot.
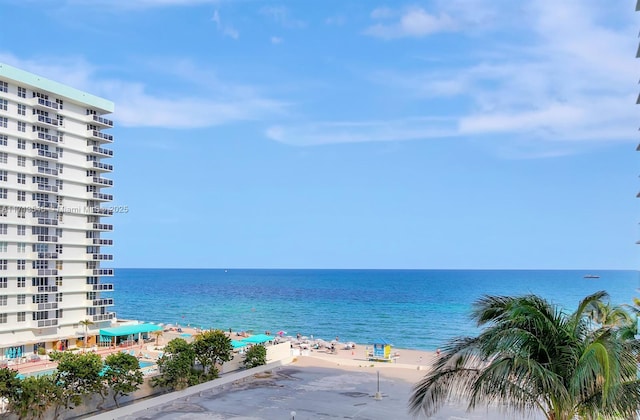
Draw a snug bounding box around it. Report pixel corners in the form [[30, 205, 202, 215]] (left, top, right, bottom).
[[152, 338, 200, 390]]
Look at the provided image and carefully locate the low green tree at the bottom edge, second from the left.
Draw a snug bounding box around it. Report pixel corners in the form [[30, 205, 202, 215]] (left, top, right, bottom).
[[9, 375, 63, 419]]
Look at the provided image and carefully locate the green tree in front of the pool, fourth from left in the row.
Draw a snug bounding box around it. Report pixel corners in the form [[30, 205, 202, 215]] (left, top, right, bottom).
[[104, 352, 144, 407]]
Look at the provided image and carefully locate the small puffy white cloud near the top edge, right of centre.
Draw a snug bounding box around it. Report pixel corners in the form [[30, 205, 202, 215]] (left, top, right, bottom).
[[364, 8, 457, 39]]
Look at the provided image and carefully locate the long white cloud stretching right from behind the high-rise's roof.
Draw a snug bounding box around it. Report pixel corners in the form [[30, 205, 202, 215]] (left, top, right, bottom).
[[0, 53, 287, 128]]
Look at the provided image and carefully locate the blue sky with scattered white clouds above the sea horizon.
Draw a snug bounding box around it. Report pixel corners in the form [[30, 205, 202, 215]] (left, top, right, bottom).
[[0, 0, 640, 269]]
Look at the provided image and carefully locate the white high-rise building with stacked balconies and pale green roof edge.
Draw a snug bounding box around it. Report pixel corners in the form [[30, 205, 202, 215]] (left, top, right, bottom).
[[0, 63, 115, 359]]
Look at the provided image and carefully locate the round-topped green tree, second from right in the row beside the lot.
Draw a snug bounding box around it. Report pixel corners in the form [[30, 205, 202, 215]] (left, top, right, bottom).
[[193, 330, 233, 379]]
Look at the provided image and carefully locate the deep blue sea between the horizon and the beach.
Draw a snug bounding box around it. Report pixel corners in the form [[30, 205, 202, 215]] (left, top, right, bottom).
[[113, 269, 640, 350]]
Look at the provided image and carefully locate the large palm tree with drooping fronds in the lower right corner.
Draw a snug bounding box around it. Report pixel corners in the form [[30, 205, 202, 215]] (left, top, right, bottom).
[[409, 292, 640, 420]]
